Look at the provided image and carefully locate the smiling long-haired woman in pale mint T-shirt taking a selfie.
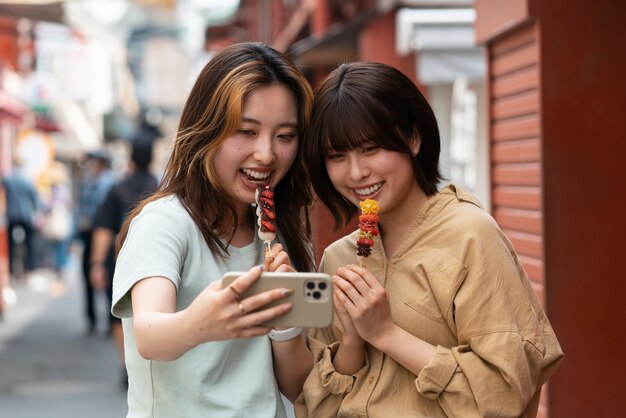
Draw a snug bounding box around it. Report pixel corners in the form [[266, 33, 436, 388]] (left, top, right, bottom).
[[112, 43, 313, 417]]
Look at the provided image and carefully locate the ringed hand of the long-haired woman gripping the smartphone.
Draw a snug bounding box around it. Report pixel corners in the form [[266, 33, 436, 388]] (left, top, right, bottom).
[[185, 266, 293, 344]]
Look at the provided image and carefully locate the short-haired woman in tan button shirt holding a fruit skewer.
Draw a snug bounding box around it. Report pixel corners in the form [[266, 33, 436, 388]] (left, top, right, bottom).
[[296, 62, 563, 418]]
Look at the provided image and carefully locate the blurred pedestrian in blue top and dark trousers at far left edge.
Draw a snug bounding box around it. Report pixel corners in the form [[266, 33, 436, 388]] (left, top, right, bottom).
[[2, 159, 41, 277]]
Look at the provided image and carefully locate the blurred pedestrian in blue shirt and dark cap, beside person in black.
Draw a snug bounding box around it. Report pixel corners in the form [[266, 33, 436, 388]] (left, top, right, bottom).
[[76, 150, 114, 334]]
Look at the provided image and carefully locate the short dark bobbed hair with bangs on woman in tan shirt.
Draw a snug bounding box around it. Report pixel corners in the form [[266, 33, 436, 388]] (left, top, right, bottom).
[[302, 62, 442, 227]]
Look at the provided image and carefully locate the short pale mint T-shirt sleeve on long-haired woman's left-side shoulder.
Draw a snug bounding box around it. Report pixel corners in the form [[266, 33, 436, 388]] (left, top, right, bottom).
[[111, 202, 187, 318]]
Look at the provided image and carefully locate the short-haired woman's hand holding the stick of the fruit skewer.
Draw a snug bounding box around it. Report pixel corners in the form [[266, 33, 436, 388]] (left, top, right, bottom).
[[333, 264, 393, 346]]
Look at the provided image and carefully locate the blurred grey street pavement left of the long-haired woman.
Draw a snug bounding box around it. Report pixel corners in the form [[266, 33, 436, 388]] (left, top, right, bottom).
[[0, 247, 126, 418]]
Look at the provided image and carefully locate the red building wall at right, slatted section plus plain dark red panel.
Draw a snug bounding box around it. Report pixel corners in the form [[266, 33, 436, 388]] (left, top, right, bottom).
[[475, 0, 626, 418]]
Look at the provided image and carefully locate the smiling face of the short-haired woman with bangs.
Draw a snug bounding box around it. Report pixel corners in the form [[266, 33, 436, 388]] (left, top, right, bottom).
[[326, 143, 421, 216]]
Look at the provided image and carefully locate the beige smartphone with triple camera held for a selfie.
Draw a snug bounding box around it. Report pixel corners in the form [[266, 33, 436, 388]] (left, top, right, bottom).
[[222, 271, 333, 328]]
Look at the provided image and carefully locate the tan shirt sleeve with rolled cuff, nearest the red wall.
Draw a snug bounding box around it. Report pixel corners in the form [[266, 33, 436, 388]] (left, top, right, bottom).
[[415, 217, 563, 417]]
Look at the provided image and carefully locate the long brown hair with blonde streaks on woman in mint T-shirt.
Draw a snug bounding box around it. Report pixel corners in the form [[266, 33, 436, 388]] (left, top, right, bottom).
[[117, 42, 314, 271]]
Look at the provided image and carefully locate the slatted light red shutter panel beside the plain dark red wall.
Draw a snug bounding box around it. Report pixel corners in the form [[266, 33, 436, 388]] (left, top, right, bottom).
[[489, 24, 544, 301]]
